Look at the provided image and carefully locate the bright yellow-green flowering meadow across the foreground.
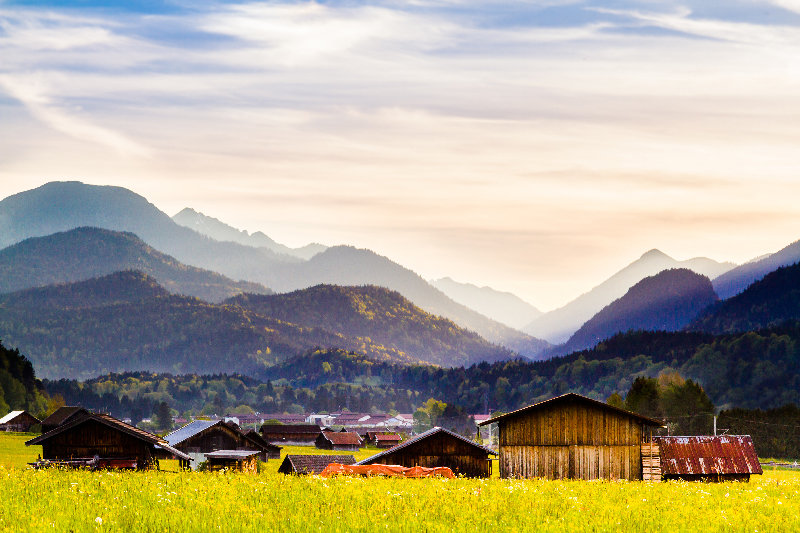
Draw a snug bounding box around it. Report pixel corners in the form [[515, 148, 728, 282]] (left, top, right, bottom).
[[0, 437, 800, 532]]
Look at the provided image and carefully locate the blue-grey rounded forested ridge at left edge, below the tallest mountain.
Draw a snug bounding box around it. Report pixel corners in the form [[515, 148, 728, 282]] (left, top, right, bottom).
[[0, 227, 271, 302]]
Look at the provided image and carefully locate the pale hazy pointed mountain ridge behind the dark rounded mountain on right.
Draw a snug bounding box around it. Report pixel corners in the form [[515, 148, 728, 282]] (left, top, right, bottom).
[[523, 250, 734, 343]]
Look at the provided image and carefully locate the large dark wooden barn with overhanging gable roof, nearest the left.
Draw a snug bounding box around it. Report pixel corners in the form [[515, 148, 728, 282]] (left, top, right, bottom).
[[25, 413, 191, 469]]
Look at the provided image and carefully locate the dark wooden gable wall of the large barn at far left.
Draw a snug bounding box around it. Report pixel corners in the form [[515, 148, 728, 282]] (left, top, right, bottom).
[[42, 420, 153, 468]]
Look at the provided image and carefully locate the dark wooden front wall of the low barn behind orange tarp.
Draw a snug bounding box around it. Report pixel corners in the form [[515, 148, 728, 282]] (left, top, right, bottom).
[[368, 433, 490, 477]]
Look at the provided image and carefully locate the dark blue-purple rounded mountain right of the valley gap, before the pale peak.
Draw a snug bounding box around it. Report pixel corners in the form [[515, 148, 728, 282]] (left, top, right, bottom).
[[558, 268, 718, 353]]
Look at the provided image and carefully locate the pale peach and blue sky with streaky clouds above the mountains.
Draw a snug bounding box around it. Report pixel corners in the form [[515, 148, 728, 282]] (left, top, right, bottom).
[[0, 0, 800, 310]]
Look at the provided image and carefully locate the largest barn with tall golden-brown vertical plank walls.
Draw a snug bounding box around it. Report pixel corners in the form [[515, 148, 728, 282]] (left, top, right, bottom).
[[478, 393, 662, 480]]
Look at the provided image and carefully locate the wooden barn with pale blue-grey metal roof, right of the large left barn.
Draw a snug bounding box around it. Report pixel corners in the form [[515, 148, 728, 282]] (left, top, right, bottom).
[[164, 420, 281, 461]]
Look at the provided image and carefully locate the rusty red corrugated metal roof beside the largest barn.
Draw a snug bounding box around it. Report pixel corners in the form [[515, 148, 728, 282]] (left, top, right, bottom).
[[653, 435, 762, 475]]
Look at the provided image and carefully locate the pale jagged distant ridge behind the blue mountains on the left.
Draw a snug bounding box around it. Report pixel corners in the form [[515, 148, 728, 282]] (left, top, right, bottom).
[[172, 207, 327, 259]]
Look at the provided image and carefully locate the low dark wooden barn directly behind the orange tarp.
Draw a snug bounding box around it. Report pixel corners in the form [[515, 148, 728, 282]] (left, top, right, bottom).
[[356, 427, 496, 477]]
